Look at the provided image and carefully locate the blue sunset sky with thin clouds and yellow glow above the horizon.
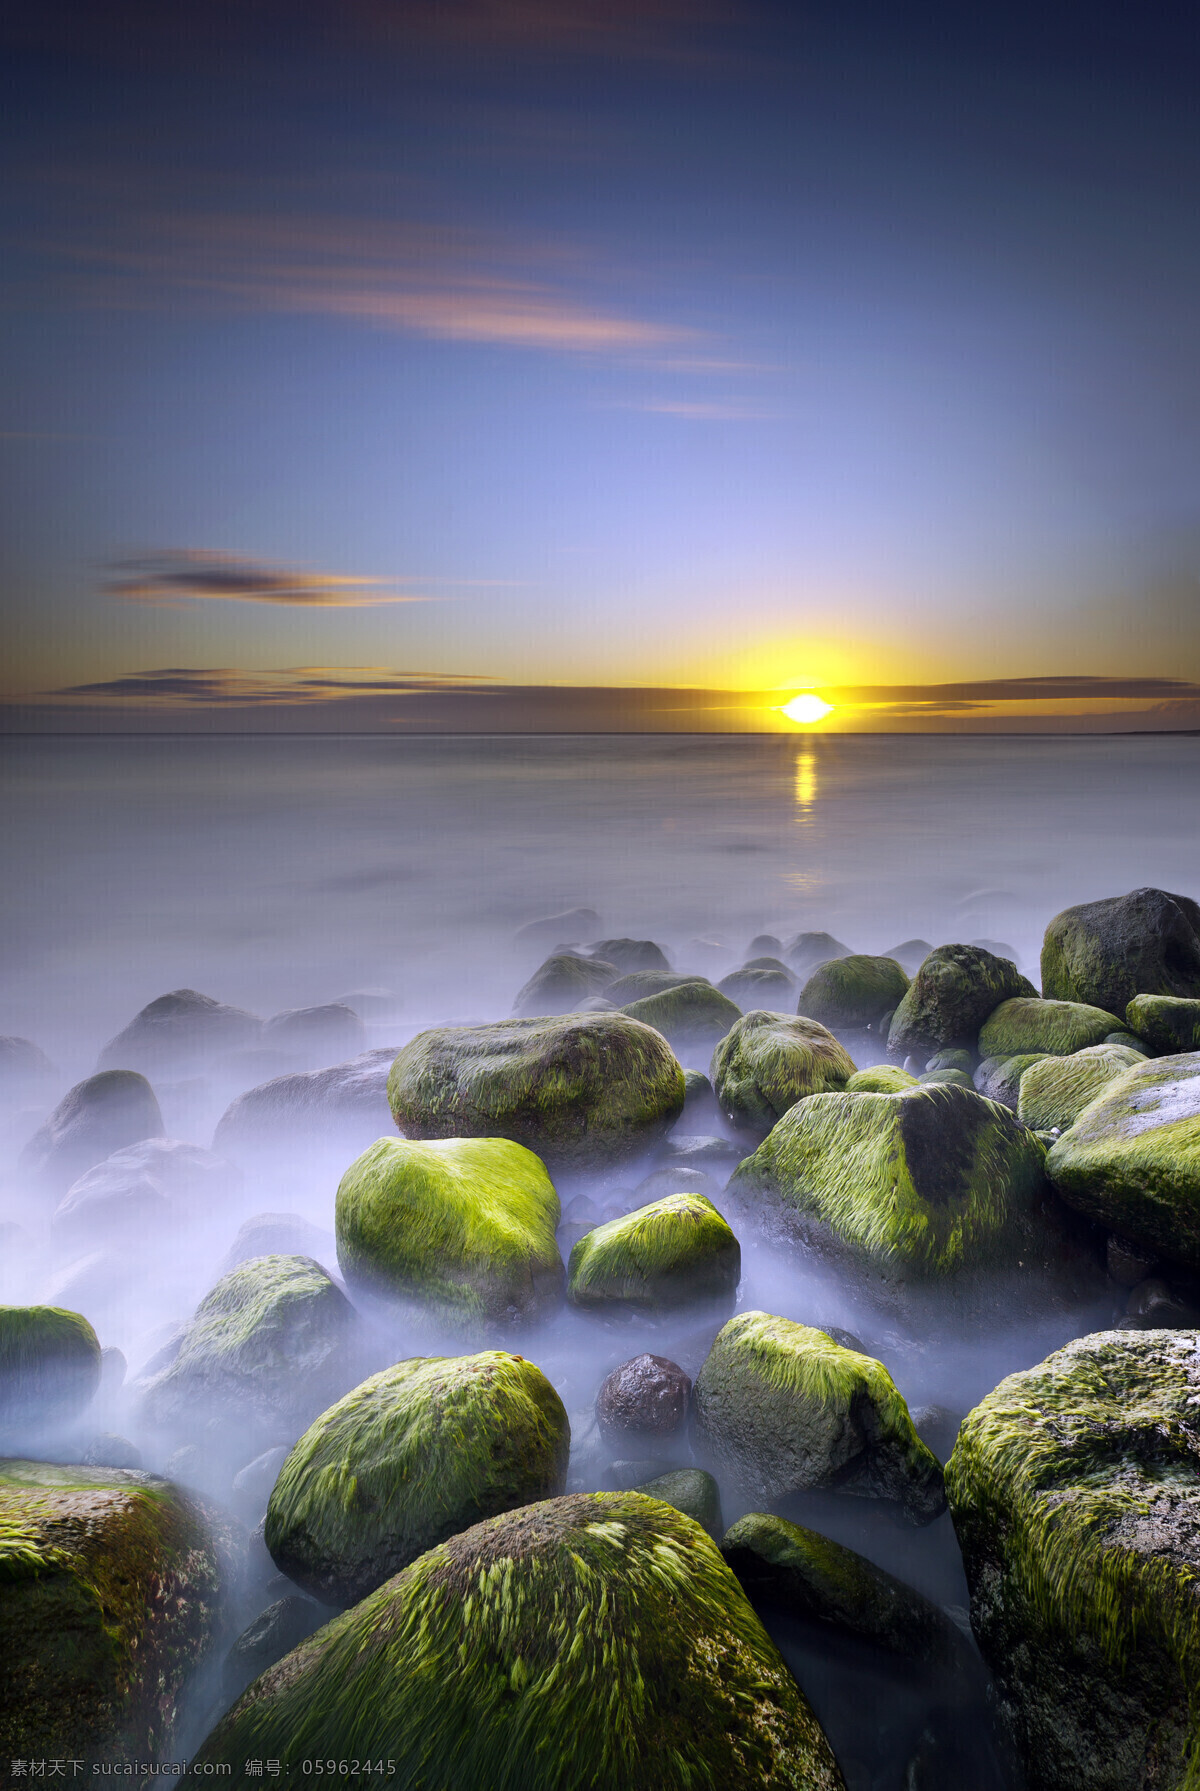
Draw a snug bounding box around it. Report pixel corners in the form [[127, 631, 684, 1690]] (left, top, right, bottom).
[[0, 0, 1200, 731]]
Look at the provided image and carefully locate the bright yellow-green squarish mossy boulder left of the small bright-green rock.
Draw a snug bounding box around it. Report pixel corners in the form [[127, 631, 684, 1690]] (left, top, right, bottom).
[[335, 1137, 562, 1322]]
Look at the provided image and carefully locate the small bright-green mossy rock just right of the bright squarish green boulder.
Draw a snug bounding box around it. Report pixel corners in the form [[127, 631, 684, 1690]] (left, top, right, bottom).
[[566, 1193, 741, 1309]]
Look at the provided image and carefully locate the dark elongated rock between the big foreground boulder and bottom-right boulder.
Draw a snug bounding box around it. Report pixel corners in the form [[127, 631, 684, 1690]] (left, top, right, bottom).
[[720, 1512, 967, 1675]]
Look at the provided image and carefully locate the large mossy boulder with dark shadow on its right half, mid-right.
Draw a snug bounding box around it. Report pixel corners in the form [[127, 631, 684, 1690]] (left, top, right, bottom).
[[729, 1084, 1059, 1295]]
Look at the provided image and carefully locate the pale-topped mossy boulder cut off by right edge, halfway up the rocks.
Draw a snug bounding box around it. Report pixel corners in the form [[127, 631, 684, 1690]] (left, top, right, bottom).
[[1046, 1051, 1200, 1270]]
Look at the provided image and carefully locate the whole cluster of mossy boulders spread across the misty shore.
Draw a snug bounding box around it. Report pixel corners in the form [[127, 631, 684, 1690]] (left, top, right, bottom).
[[0, 890, 1200, 1791]]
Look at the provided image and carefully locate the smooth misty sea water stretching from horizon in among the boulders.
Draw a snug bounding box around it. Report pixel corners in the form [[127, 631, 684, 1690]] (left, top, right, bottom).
[[0, 736, 1200, 1791]]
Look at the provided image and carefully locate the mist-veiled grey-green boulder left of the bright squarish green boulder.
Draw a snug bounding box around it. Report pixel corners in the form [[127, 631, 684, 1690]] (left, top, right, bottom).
[[143, 1255, 355, 1440]]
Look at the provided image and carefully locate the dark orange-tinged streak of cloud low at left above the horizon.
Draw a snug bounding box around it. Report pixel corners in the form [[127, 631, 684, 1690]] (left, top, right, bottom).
[[104, 548, 435, 609]]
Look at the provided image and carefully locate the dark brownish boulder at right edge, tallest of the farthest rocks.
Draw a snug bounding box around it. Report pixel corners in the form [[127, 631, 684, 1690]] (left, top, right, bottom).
[[1042, 888, 1200, 1014]]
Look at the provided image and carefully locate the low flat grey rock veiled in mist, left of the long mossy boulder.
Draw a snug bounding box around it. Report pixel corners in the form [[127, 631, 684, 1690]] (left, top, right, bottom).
[[213, 1046, 396, 1157]]
